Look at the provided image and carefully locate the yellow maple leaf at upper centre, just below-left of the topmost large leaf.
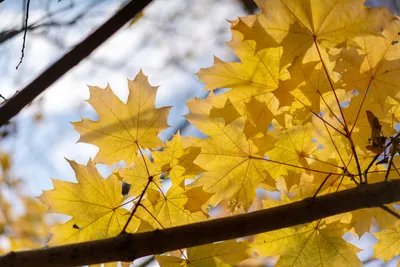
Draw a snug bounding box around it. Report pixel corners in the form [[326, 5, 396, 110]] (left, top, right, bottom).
[[197, 25, 290, 125]]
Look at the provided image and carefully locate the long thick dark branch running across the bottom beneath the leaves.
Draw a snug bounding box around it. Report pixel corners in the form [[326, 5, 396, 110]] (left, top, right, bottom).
[[0, 180, 400, 267]]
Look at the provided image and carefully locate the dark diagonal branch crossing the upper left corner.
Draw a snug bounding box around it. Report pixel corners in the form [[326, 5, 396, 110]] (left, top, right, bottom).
[[0, 0, 152, 126]]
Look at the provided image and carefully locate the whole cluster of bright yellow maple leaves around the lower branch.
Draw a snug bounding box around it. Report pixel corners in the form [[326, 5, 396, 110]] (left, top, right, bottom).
[[36, 0, 400, 266]]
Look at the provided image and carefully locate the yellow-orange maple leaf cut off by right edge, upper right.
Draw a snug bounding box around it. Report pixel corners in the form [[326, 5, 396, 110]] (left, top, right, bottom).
[[335, 19, 400, 108]]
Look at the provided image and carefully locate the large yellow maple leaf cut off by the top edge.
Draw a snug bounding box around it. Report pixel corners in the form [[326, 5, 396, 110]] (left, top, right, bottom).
[[233, 0, 393, 63]]
